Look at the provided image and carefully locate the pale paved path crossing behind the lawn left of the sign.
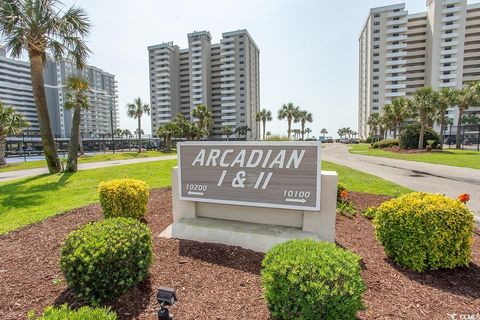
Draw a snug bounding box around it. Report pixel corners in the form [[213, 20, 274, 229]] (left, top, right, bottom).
[[0, 155, 177, 182]]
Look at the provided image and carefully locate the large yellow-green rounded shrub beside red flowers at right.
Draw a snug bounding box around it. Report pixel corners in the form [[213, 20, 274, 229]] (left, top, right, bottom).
[[373, 192, 474, 272]]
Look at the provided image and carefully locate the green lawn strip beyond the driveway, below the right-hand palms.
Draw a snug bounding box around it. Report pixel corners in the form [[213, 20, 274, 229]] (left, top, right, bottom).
[[349, 143, 480, 169]]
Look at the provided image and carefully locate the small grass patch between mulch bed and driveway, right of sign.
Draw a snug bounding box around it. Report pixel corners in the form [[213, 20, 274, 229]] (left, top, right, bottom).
[[322, 161, 412, 197]]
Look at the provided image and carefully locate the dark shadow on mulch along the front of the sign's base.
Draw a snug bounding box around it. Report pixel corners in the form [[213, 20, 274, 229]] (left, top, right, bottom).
[[179, 240, 265, 275]]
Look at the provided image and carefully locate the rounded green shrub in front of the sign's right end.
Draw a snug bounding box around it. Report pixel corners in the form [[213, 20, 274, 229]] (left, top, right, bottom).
[[262, 239, 365, 320]]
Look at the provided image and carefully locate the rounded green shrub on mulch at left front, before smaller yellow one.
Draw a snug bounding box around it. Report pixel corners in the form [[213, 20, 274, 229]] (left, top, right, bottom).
[[60, 218, 152, 304]]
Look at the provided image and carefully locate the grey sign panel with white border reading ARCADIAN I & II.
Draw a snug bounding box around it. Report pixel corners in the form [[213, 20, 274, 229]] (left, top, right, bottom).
[[177, 141, 321, 211]]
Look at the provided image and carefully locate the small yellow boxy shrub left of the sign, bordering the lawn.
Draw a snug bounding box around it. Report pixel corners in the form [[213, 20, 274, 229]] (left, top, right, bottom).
[[98, 179, 150, 219]]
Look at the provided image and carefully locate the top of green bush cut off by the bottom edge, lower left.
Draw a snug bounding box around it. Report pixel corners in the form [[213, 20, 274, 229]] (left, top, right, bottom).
[[28, 304, 117, 320]]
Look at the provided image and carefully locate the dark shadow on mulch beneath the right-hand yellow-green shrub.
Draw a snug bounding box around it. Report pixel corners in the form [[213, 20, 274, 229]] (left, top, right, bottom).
[[385, 258, 480, 299]]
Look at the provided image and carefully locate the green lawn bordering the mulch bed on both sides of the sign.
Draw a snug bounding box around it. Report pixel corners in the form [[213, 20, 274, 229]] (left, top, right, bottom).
[[0, 160, 410, 234]]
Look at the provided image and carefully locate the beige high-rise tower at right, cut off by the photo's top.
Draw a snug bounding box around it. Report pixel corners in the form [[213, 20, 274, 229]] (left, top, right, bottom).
[[358, 0, 480, 138]]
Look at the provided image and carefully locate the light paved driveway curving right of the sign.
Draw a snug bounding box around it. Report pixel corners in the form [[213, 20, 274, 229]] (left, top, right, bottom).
[[322, 144, 480, 220]]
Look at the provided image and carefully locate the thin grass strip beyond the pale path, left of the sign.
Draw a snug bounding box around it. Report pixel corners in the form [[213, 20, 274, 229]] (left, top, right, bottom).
[[0, 151, 176, 172]]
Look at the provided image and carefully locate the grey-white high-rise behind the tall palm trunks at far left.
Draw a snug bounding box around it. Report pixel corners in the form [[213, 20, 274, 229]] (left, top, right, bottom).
[[0, 48, 119, 138]]
